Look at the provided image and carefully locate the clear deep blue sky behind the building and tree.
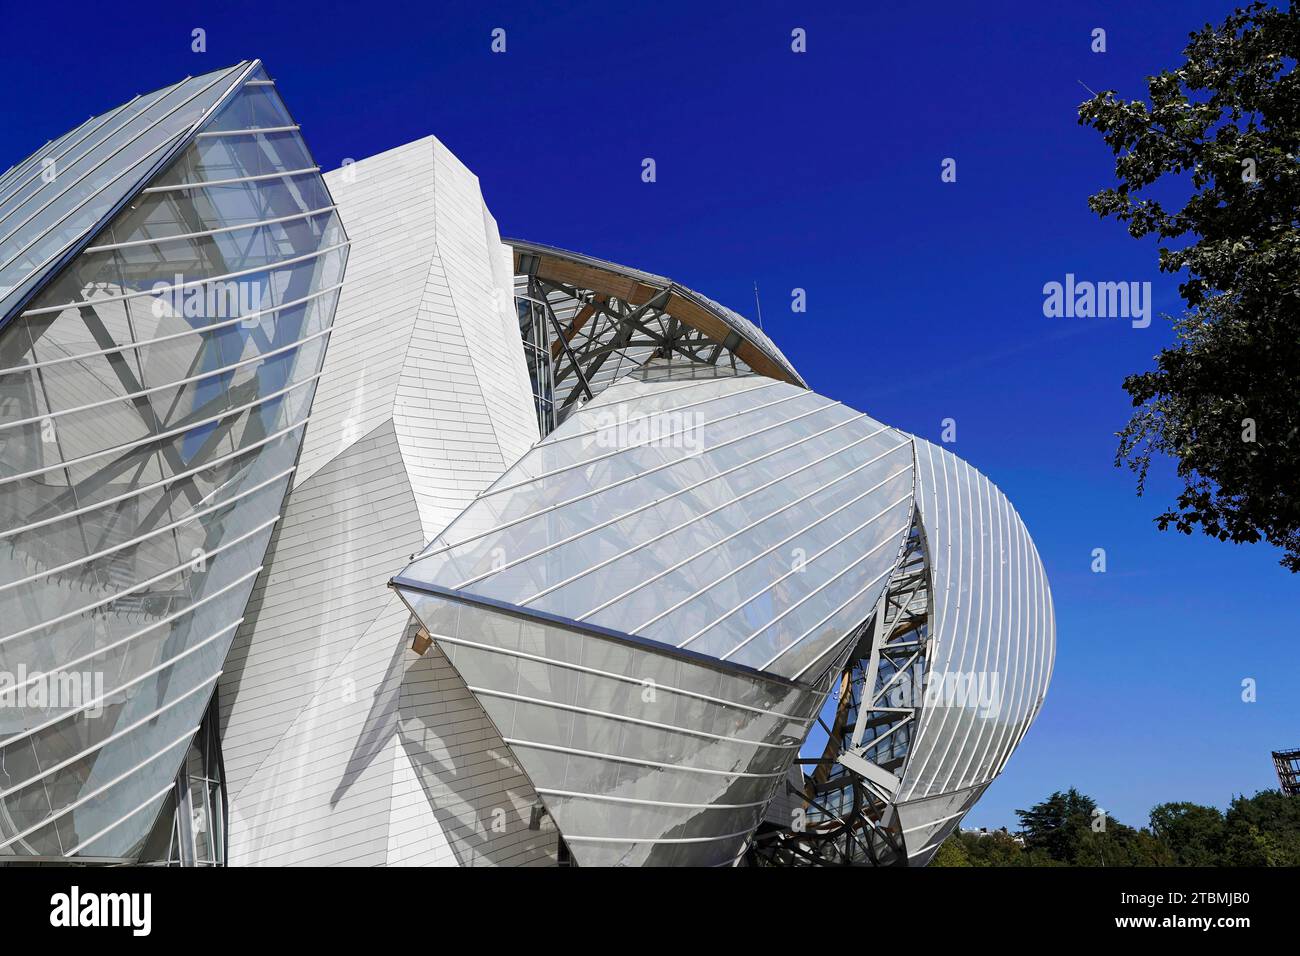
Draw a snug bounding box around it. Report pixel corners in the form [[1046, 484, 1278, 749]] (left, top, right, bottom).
[[0, 0, 1300, 826]]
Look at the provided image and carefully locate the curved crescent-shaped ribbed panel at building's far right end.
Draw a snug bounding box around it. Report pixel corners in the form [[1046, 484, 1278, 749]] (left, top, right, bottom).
[[898, 438, 1056, 801]]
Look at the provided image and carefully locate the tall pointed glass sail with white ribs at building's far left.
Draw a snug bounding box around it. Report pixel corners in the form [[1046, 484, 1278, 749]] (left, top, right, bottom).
[[0, 64, 347, 858]]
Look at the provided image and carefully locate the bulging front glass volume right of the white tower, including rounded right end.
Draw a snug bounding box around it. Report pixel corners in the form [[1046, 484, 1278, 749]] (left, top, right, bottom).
[[394, 360, 1053, 865]]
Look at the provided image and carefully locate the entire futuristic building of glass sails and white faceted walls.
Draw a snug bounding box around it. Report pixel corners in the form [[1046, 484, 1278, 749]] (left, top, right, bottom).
[[0, 61, 1054, 866]]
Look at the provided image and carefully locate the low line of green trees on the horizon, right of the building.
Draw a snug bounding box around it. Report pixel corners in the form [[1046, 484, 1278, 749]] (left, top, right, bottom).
[[930, 787, 1300, 866]]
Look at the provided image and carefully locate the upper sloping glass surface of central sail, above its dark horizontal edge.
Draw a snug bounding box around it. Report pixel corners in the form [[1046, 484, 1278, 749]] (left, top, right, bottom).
[[399, 375, 913, 680]]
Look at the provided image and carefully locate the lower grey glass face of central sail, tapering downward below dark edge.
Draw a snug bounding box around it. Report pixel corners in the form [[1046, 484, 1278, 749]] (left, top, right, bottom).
[[399, 587, 827, 866]]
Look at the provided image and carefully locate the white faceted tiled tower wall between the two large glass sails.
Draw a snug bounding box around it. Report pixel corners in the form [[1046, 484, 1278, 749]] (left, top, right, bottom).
[[221, 138, 556, 866]]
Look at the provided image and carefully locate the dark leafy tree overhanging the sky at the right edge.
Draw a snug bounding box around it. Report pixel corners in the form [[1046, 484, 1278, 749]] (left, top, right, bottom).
[[1079, 3, 1300, 571]]
